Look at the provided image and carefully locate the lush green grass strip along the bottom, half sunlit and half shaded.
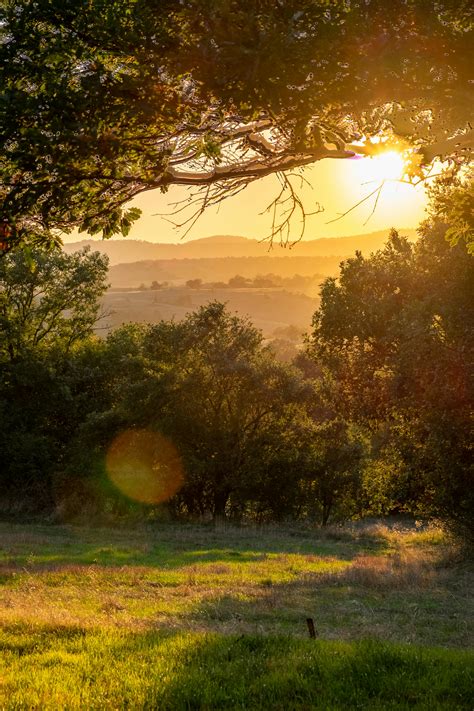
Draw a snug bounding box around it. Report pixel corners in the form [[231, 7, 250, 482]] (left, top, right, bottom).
[[0, 626, 474, 711]]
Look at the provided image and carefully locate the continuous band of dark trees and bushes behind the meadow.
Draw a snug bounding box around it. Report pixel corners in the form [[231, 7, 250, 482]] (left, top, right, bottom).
[[0, 182, 474, 538]]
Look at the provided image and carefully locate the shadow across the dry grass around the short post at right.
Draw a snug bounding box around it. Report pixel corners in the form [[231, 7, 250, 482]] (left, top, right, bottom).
[[180, 566, 474, 648]]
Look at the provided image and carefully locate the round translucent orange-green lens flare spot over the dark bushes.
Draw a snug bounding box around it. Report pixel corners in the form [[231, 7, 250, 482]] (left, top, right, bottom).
[[106, 430, 184, 504]]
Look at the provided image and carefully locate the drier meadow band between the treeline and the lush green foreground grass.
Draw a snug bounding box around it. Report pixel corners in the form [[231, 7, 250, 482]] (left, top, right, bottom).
[[0, 524, 474, 647]]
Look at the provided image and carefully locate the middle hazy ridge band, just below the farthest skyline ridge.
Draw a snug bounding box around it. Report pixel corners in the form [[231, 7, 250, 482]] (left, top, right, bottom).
[[109, 251, 341, 289]]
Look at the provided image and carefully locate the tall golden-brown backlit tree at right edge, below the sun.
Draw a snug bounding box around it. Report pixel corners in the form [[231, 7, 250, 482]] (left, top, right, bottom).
[[312, 179, 474, 538]]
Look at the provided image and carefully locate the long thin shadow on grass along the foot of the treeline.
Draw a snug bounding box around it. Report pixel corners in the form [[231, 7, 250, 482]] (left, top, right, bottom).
[[0, 525, 387, 584]]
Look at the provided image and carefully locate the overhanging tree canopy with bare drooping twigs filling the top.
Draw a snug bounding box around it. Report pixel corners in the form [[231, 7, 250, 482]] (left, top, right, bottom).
[[0, 0, 473, 251]]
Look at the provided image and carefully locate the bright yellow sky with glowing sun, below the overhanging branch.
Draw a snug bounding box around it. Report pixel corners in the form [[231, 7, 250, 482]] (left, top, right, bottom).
[[67, 158, 426, 242]]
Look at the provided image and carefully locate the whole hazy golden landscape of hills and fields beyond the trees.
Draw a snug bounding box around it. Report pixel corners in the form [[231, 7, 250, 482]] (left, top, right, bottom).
[[69, 229, 416, 343]]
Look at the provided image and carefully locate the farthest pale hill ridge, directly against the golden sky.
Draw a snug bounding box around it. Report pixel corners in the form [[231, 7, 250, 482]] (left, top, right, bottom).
[[64, 229, 416, 265]]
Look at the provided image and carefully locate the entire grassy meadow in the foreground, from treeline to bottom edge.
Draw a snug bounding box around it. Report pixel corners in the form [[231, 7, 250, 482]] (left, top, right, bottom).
[[0, 524, 474, 710]]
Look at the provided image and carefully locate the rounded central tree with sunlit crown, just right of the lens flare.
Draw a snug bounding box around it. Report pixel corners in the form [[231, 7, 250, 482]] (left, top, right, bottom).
[[143, 302, 312, 517]]
